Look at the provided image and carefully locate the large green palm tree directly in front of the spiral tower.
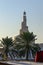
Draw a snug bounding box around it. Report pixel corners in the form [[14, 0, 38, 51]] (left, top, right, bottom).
[[15, 32, 39, 60]]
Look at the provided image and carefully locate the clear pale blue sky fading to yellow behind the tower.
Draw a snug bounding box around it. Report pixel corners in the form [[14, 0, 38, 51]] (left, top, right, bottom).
[[0, 0, 43, 43]]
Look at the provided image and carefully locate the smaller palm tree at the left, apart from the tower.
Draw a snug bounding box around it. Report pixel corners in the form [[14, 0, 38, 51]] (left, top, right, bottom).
[[1, 36, 13, 59]]
